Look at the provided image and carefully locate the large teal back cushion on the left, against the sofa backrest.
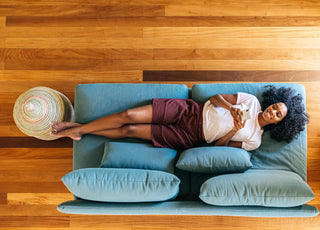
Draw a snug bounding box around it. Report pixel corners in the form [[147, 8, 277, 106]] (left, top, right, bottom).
[[62, 168, 180, 202]]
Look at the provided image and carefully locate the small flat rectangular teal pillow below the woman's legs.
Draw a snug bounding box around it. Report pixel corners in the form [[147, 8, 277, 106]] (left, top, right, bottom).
[[100, 142, 177, 173]]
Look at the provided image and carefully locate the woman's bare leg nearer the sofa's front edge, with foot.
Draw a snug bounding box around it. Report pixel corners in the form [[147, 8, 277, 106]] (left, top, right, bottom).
[[51, 105, 153, 140]]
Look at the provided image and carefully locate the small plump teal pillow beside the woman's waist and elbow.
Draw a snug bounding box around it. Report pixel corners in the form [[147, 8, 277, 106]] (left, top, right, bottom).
[[176, 146, 252, 174]]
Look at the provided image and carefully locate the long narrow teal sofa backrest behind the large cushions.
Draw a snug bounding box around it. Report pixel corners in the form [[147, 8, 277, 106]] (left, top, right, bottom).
[[58, 199, 319, 217]]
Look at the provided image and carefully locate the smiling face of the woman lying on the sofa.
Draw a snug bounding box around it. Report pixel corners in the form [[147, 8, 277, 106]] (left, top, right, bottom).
[[262, 102, 288, 124]]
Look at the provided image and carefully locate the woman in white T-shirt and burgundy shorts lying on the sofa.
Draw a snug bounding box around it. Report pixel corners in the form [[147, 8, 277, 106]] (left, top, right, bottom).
[[50, 86, 308, 150]]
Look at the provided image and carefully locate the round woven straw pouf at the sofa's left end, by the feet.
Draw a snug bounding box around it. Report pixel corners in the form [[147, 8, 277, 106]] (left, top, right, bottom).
[[13, 86, 74, 140]]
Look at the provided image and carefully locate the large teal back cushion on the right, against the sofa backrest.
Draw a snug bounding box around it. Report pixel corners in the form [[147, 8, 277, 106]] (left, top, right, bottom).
[[199, 169, 314, 207]]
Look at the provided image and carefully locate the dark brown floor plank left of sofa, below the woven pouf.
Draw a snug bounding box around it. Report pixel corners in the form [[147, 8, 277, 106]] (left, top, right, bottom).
[[0, 137, 73, 148]]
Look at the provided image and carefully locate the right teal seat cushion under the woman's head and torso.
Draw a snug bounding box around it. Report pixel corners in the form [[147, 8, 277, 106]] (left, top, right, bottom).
[[192, 83, 307, 181]]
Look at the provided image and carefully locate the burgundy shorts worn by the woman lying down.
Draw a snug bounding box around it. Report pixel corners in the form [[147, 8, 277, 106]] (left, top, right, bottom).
[[151, 98, 205, 149]]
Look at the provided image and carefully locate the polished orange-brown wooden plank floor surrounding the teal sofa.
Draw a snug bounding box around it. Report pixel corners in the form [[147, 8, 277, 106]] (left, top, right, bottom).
[[0, 0, 320, 230]]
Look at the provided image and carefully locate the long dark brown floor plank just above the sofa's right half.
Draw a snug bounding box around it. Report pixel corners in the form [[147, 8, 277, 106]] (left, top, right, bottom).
[[143, 71, 320, 82]]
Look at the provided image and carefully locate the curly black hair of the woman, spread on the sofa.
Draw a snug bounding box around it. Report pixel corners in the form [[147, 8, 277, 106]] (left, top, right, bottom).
[[261, 85, 309, 143]]
